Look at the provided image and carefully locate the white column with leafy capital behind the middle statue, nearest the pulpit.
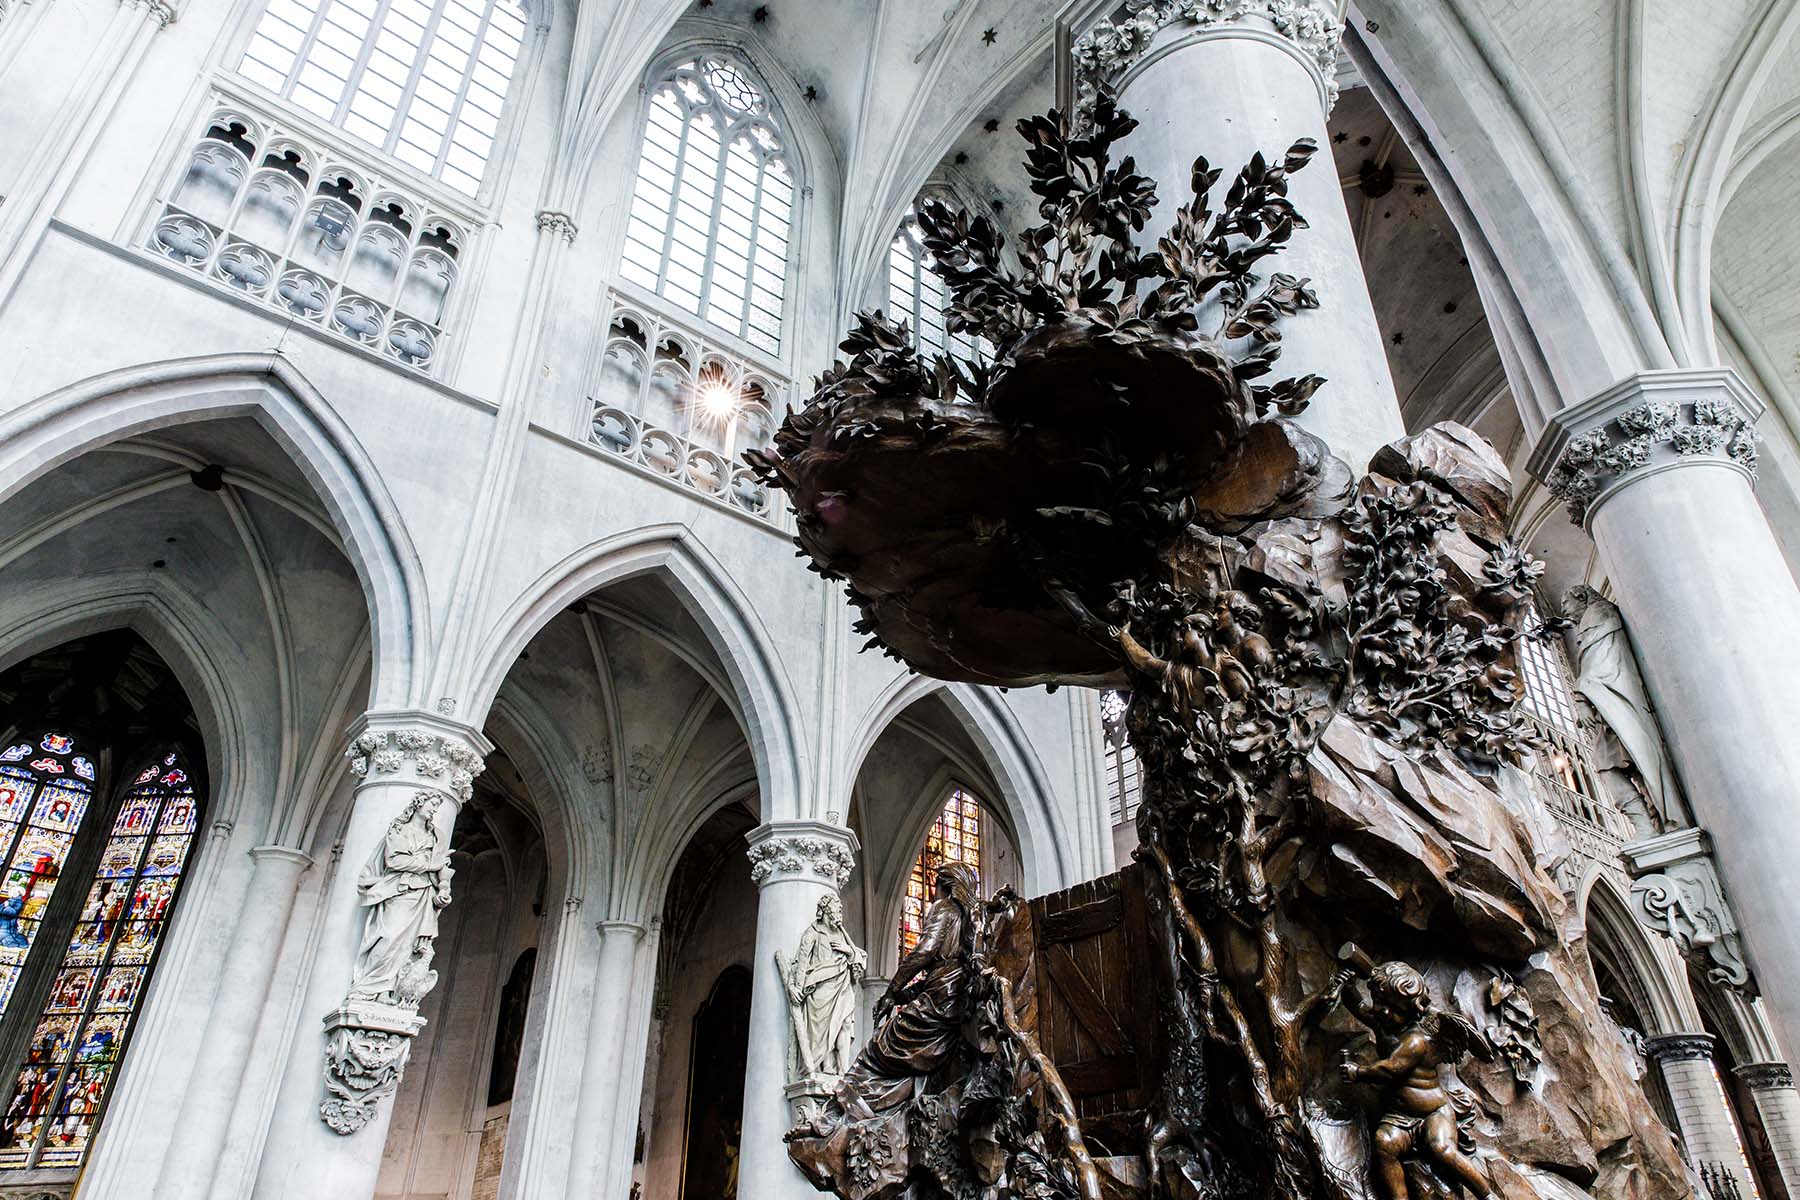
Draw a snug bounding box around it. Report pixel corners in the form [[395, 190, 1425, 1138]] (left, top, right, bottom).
[[738, 820, 859, 1200]]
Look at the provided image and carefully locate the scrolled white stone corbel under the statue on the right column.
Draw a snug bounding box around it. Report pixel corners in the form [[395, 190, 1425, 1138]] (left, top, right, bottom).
[[1622, 829, 1755, 993]]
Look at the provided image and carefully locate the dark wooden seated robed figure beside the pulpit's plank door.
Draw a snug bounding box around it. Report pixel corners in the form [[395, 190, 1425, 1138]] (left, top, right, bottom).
[[839, 862, 979, 1119]]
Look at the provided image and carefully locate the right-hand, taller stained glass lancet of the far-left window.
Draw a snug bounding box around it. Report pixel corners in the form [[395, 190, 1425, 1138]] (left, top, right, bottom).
[[0, 754, 198, 1169]]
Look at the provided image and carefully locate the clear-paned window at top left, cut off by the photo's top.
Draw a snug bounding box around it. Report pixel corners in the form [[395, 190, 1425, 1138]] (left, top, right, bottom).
[[238, 0, 526, 196]]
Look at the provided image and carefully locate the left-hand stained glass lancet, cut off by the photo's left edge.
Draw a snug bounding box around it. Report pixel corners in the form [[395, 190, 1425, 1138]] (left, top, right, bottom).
[[0, 730, 94, 1015]]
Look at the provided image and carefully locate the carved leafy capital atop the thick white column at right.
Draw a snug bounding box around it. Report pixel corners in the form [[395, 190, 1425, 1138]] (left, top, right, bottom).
[[1546, 396, 1759, 524]]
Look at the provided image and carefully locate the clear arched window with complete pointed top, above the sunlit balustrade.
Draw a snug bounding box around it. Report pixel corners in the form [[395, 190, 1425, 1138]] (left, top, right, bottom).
[[619, 54, 794, 354]]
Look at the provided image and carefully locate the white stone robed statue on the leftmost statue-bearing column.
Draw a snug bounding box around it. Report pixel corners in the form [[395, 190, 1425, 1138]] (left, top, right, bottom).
[[349, 792, 452, 1004]]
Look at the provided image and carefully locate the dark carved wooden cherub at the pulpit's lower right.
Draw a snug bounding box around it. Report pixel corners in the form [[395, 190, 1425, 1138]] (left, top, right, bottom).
[[1332, 963, 1494, 1200]]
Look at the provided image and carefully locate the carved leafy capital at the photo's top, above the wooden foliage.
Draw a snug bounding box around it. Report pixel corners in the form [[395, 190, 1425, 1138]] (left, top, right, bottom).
[[1057, 0, 1343, 113]]
